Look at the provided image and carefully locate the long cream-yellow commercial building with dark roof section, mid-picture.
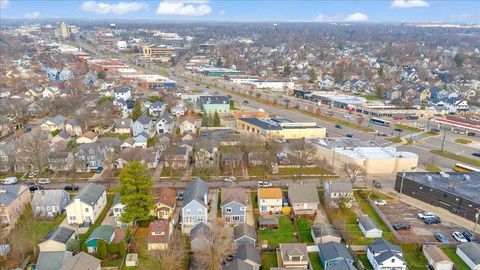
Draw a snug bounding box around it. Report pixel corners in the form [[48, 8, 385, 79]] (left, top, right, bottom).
[[237, 117, 326, 139]]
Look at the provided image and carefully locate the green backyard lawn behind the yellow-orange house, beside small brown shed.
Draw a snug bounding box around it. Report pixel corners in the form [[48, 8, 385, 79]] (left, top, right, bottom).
[[257, 216, 298, 247]]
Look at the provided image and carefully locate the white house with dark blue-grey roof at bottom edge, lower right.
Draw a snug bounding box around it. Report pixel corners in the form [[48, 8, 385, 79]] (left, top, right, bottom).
[[367, 238, 407, 270]]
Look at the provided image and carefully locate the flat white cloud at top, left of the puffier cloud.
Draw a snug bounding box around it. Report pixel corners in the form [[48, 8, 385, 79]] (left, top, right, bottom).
[[82, 1, 148, 15]]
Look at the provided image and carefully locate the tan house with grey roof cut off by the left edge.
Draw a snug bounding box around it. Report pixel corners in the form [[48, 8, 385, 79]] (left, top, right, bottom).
[[0, 185, 31, 231]]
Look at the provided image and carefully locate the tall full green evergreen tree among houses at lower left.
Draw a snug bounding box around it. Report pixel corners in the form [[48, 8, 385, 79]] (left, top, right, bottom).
[[119, 161, 153, 223]]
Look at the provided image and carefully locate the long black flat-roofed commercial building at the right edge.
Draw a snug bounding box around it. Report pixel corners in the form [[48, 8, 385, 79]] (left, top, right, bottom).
[[395, 172, 480, 221]]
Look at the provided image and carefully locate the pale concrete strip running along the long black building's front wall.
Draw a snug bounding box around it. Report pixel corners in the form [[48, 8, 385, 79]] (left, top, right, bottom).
[[386, 190, 480, 234]]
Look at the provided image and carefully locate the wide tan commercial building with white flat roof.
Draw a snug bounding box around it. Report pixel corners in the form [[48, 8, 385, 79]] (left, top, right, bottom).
[[311, 138, 418, 174]]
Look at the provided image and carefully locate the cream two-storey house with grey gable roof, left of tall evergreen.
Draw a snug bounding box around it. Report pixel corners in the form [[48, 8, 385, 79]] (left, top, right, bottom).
[[65, 183, 107, 224]]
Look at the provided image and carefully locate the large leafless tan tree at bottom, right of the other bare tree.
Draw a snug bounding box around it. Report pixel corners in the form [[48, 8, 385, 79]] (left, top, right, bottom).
[[194, 221, 236, 270]]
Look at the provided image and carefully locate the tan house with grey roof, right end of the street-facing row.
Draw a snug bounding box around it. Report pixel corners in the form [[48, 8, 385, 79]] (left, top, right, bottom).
[[325, 180, 353, 208]]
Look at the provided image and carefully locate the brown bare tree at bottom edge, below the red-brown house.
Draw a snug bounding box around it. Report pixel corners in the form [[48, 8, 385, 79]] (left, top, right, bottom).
[[152, 231, 187, 270]]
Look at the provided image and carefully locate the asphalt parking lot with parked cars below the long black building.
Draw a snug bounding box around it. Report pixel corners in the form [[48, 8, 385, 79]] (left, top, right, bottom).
[[379, 200, 478, 243]]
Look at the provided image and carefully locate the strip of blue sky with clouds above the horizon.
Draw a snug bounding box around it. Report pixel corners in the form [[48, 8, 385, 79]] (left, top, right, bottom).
[[0, 0, 480, 23]]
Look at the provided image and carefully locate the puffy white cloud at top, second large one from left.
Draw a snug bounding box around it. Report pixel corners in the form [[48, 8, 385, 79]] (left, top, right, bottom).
[[157, 0, 212, 16]]
